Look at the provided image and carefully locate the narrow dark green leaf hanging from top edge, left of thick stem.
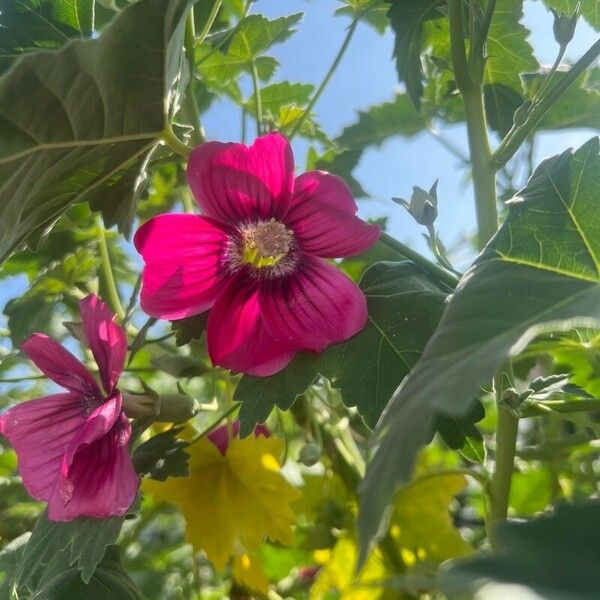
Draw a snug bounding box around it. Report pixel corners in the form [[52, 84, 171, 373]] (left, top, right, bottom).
[[388, 0, 443, 110]]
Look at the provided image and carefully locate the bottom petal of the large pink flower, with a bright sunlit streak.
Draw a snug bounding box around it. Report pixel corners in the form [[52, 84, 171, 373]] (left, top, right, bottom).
[[207, 273, 295, 376]]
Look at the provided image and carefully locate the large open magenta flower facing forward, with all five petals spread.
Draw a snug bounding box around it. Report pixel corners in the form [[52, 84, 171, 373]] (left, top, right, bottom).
[[134, 133, 379, 375]]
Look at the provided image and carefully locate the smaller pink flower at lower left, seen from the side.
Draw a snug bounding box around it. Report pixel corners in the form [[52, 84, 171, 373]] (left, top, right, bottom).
[[0, 294, 138, 521]]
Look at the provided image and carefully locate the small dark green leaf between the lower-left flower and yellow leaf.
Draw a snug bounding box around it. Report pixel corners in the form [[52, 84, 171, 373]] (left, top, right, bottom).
[[133, 427, 190, 481]]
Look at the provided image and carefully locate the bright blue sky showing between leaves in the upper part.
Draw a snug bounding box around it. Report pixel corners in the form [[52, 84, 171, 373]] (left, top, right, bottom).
[[203, 0, 595, 262]]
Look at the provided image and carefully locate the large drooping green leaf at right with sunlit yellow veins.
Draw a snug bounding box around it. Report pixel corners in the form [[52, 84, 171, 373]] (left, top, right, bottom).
[[359, 138, 600, 554]]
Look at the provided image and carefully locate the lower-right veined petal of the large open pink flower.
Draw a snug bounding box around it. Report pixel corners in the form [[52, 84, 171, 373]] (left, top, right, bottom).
[[260, 254, 367, 352]]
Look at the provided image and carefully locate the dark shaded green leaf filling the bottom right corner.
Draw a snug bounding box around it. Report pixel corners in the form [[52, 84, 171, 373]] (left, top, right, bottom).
[[440, 502, 600, 600]]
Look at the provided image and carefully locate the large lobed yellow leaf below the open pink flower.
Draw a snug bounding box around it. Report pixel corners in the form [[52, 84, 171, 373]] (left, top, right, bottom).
[[144, 436, 299, 570]]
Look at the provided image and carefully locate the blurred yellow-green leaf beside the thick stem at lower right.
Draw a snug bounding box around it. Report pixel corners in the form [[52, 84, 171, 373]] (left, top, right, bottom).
[[390, 474, 471, 567]]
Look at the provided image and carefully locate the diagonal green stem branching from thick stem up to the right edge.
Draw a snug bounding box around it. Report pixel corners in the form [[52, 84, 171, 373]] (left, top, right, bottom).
[[491, 39, 600, 170]]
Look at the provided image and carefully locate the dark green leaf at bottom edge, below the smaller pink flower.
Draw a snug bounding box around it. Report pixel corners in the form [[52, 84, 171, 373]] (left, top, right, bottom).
[[30, 546, 143, 600]]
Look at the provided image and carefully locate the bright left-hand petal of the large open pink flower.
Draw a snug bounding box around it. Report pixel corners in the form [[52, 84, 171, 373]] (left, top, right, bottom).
[[134, 214, 229, 320]]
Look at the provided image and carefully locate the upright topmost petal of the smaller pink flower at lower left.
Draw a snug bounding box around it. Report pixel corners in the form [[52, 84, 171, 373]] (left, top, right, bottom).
[[79, 294, 127, 394]]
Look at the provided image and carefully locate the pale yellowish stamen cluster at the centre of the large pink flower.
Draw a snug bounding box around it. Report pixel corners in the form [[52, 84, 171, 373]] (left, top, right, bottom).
[[242, 219, 293, 269]]
